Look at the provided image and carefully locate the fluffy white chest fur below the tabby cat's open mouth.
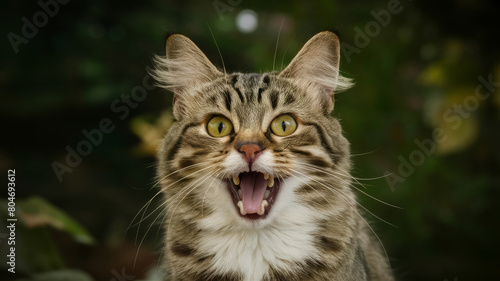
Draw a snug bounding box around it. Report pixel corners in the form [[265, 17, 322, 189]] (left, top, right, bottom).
[[198, 184, 318, 281]]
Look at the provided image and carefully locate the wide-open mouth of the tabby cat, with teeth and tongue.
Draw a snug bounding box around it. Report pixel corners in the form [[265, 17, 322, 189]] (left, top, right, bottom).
[[227, 172, 280, 219]]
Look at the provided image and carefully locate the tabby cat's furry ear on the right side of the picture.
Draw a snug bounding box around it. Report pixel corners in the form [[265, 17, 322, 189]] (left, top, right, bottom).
[[279, 31, 353, 113]]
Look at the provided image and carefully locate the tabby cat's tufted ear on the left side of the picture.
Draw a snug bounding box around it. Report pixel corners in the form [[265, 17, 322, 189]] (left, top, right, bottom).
[[153, 34, 224, 118]]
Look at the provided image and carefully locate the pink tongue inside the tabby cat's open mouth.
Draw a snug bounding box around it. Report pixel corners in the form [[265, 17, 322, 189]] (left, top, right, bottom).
[[240, 172, 267, 214]]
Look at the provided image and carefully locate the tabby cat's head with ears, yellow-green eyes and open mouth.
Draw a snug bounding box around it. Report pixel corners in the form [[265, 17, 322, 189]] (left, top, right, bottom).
[[154, 31, 352, 228]]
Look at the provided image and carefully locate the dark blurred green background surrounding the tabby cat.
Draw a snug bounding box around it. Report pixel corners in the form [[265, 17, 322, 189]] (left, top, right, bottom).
[[0, 0, 500, 281]]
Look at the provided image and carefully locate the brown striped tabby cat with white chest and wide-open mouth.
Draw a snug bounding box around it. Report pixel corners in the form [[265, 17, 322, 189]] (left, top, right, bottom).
[[153, 31, 394, 281]]
